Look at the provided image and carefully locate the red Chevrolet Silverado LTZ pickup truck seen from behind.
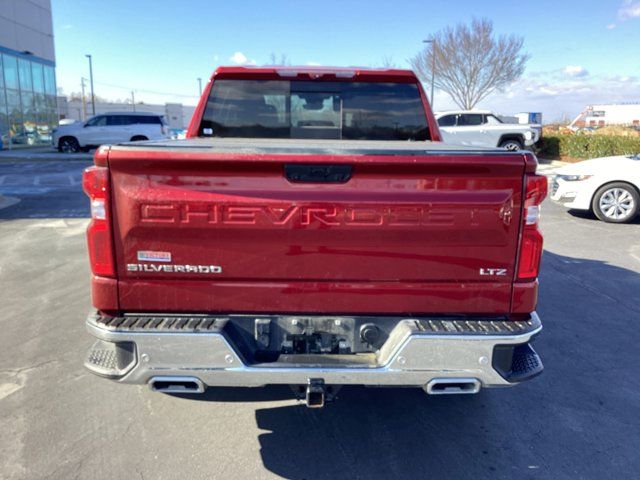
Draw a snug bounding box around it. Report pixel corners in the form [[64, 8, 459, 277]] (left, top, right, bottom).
[[83, 67, 547, 407]]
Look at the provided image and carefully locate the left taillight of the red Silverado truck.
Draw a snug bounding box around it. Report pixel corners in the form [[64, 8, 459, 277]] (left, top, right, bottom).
[[82, 167, 115, 277]]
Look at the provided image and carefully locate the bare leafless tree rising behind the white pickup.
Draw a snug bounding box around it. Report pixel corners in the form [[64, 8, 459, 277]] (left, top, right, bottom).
[[409, 19, 529, 110]]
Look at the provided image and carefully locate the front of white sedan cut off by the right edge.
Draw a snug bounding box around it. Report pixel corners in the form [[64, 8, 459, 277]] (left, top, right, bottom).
[[551, 155, 640, 223]]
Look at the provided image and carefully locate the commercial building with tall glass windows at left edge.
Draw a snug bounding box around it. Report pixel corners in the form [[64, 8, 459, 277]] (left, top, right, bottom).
[[0, 0, 58, 148]]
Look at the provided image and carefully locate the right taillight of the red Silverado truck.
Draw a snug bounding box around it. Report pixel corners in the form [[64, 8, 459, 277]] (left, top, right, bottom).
[[517, 175, 547, 281]]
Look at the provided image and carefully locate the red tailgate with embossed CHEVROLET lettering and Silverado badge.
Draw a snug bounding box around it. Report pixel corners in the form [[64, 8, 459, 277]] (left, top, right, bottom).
[[109, 147, 524, 314]]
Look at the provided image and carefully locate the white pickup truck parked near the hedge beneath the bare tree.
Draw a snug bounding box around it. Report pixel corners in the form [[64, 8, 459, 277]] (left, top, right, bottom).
[[435, 110, 540, 150]]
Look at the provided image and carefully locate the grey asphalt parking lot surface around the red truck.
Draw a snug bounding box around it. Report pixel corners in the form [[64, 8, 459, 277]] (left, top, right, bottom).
[[0, 160, 640, 480]]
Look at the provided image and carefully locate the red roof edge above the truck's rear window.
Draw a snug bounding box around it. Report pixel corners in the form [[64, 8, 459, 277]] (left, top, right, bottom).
[[212, 65, 418, 83]]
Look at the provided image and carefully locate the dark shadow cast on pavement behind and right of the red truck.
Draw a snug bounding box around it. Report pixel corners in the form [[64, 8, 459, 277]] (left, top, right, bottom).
[[170, 251, 640, 480]]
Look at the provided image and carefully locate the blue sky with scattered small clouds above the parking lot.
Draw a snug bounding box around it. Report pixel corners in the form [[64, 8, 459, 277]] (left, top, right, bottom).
[[52, 0, 640, 120]]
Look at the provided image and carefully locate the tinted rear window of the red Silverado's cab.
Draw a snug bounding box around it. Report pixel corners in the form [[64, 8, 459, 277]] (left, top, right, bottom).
[[199, 80, 429, 140]]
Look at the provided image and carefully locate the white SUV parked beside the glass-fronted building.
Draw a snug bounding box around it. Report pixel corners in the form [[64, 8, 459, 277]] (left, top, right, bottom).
[[51, 112, 169, 152]]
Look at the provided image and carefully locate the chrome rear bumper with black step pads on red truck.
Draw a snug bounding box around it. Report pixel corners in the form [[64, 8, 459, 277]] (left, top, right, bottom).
[[85, 313, 542, 393]]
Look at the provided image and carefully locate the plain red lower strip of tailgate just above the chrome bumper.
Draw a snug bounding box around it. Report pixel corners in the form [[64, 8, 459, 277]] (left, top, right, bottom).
[[119, 279, 511, 315]]
